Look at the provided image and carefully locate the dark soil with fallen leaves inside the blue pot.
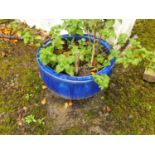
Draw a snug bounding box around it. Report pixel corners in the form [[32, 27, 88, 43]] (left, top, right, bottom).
[[45, 39, 108, 76]]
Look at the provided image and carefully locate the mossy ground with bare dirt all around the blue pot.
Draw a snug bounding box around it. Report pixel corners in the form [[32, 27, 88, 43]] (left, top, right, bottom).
[[0, 20, 155, 134]]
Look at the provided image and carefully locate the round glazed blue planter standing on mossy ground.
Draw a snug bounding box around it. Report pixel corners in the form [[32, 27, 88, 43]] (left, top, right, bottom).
[[37, 35, 115, 100]]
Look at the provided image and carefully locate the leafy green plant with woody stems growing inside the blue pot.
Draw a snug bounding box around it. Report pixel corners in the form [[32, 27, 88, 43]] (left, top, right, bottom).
[[40, 19, 114, 75]]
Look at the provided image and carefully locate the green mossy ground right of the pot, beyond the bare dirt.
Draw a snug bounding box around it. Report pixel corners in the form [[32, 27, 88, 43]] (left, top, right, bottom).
[[100, 64, 155, 134]]
